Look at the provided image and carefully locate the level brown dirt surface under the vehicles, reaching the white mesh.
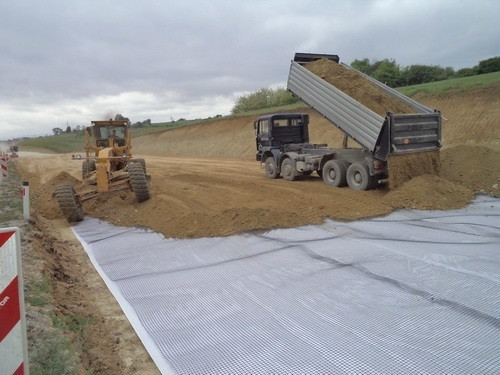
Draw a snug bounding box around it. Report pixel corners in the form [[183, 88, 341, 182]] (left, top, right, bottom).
[[18, 147, 500, 237]]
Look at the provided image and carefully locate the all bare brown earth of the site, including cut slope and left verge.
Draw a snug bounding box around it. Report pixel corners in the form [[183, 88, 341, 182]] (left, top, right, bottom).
[[9, 83, 500, 374]]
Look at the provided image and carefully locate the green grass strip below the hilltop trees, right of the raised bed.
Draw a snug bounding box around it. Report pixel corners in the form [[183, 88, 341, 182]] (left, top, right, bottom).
[[397, 72, 500, 97]]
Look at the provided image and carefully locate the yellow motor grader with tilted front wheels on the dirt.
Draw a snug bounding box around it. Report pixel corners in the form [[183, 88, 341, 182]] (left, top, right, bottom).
[[53, 120, 149, 222]]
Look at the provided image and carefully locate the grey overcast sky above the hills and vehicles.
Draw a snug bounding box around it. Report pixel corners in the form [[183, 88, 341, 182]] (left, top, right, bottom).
[[0, 0, 500, 139]]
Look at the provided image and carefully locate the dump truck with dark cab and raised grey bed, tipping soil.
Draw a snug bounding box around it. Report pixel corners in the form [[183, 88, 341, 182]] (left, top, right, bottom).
[[254, 53, 441, 190]]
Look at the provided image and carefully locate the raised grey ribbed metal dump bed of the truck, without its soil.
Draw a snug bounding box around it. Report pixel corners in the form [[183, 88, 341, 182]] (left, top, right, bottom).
[[288, 54, 441, 160]]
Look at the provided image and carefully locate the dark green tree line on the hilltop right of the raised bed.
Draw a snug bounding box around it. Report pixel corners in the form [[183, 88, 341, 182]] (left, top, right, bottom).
[[351, 56, 500, 87]]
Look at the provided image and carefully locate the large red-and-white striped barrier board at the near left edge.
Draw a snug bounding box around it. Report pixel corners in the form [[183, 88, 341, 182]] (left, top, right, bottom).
[[0, 228, 28, 375]]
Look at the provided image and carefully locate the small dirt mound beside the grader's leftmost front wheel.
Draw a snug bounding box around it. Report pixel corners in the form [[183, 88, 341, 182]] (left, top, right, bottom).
[[33, 172, 83, 220]]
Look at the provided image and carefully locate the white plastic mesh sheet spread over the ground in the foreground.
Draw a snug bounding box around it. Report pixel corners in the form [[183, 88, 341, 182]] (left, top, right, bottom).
[[73, 197, 500, 374]]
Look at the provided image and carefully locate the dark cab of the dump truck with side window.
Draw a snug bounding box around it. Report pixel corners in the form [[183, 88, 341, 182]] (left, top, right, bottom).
[[254, 113, 309, 161]]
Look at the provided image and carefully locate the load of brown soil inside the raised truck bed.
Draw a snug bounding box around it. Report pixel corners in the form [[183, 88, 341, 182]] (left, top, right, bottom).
[[305, 59, 415, 117]]
